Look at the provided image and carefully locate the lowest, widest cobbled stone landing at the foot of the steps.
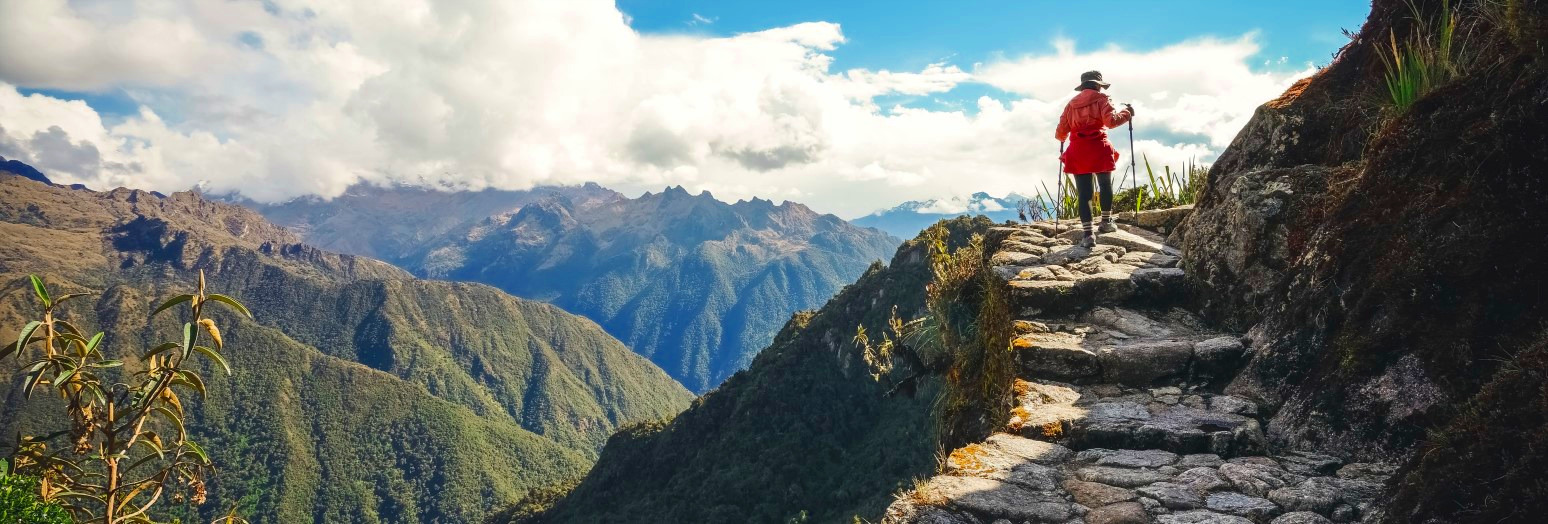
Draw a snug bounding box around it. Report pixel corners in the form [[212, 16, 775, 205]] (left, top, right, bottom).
[[884, 433, 1393, 524]]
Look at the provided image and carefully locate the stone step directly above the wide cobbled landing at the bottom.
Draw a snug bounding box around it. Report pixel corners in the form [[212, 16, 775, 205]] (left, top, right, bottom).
[[1008, 380, 1266, 458]]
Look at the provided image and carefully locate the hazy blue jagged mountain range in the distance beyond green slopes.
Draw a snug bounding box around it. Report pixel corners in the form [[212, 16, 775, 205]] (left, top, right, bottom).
[[248, 184, 898, 391]]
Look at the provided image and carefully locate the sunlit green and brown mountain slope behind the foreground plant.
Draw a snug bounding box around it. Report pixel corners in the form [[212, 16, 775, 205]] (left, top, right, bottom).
[[0, 173, 692, 522]]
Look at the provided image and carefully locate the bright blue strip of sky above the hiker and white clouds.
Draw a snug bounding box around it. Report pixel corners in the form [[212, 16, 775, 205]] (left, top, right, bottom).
[[618, 0, 1370, 71]]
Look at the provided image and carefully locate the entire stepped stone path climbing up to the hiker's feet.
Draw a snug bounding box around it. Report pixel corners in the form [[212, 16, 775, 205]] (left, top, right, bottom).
[[884, 210, 1392, 524]]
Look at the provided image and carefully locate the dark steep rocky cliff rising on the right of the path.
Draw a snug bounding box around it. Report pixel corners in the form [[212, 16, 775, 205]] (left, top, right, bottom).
[[1172, 0, 1548, 522]]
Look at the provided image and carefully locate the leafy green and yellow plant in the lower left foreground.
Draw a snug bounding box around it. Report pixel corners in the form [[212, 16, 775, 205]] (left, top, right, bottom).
[[0, 272, 252, 524]]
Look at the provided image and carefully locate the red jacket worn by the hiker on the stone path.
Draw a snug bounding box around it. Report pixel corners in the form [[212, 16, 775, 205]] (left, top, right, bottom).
[[1054, 90, 1133, 175]]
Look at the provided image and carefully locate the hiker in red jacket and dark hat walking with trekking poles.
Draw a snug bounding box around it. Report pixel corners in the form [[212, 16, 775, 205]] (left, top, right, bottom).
[[1054, 71, 1135, 247]]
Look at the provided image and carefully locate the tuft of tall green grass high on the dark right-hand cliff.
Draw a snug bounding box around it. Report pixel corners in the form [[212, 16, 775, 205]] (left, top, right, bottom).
[[1378, 0, 1460, 111]]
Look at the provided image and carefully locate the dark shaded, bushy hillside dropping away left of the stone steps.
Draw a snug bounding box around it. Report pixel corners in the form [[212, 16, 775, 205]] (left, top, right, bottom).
[[512, 218, 1009, 522]]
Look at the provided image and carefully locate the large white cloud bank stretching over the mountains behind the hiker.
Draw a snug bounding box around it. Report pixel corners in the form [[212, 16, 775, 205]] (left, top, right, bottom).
[[0, 0, 1311, 216]]
